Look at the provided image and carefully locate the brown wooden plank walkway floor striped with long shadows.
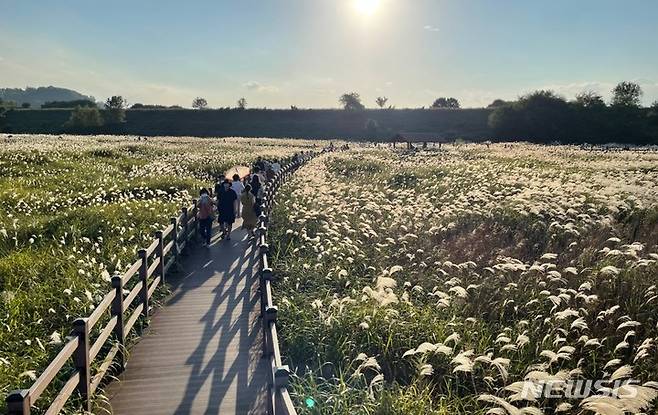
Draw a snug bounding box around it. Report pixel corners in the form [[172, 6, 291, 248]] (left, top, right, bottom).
[[107, 219, 268, 415]]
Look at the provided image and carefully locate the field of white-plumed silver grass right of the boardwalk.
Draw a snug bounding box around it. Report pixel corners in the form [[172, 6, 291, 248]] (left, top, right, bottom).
[[270, 144, 658, 415]]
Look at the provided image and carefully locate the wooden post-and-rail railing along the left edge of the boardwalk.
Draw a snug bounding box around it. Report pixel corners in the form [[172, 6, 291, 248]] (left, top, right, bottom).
[[6, 201, 198, 415]]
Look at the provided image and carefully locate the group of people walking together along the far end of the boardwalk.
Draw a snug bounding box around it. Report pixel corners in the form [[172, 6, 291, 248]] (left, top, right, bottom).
[[197, 151, 311, 245]]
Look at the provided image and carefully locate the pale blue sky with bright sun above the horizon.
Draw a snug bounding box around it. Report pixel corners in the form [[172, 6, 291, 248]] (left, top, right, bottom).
[[0, 0, 658, 108]]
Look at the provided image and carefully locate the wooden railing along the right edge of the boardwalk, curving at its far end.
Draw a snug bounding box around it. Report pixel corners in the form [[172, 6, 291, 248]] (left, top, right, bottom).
[[258, 154, 314, 415]]
